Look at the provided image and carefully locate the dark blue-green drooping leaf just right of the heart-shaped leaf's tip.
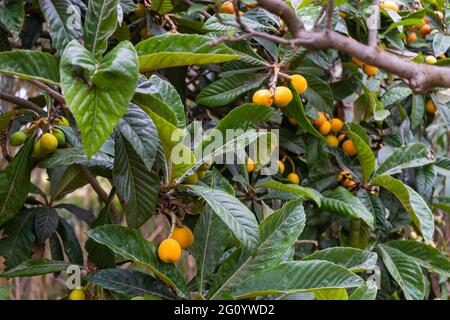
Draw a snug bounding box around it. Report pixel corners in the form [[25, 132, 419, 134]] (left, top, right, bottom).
[[119, 105, 159, 170]]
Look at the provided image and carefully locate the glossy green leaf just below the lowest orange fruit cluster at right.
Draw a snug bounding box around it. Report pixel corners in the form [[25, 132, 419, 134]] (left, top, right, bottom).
[[321, 187, 374, 227]]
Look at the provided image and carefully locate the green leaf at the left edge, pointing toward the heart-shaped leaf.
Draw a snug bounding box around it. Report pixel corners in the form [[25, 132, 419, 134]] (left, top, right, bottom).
[[0, 50, 59, 85]]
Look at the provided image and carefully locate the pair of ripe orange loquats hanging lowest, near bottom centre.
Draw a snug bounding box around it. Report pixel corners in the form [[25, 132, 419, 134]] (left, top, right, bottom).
[[158, 225, 194, 263]]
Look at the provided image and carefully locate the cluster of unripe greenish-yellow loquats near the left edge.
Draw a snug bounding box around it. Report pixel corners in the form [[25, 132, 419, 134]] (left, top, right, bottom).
[[9, 116, 69, 159]]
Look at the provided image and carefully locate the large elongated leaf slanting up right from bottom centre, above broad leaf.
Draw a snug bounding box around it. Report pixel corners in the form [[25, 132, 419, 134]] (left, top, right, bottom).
[[210, 200, 305, 299]]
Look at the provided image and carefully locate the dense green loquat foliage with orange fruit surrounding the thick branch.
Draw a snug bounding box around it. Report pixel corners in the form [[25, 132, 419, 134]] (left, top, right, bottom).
[[0, 0, 450, 300]]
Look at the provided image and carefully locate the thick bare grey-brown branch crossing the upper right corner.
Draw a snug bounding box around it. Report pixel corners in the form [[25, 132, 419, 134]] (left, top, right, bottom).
[[257, 0, 450, 93]]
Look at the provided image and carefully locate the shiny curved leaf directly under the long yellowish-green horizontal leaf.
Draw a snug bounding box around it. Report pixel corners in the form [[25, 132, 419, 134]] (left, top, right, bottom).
[[133, 74, 186, 128]]
